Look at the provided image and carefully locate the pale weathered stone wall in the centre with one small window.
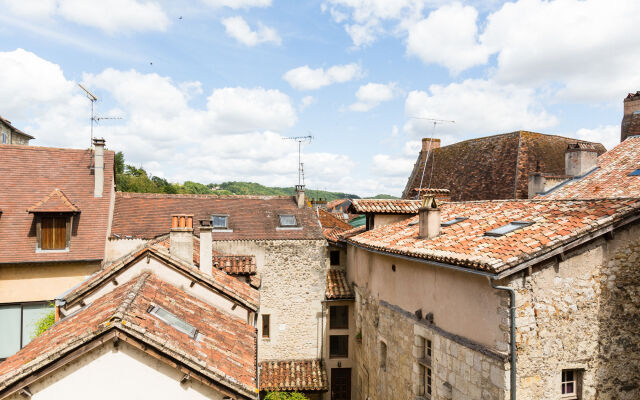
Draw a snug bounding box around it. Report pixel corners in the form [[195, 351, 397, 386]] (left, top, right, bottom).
[[213, 240, 328, 361]]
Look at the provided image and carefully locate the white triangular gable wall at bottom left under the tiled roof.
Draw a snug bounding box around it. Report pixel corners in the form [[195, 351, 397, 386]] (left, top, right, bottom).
[[9, 341, 223, 400]]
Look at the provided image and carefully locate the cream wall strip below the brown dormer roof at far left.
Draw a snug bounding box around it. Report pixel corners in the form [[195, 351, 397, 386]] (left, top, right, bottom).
[[0, 263, 100, 303]]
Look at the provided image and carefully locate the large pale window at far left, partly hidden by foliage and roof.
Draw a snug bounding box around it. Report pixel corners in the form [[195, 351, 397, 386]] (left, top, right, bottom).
[[0, 302, 52, 360]]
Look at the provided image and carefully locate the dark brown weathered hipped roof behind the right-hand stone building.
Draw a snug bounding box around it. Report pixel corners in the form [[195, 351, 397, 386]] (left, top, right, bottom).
[[402, 131, 606, 201]]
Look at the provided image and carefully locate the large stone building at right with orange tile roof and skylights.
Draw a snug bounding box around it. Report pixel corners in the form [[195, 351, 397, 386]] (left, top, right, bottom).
[[347, 198, 640, 400]]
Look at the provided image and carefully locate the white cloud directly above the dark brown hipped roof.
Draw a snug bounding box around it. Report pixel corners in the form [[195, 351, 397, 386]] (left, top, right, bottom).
[[404, 79, 557, 140]]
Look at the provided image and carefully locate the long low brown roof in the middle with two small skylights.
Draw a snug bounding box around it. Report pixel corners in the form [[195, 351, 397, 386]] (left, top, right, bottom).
[[111, 192, 323, 240]]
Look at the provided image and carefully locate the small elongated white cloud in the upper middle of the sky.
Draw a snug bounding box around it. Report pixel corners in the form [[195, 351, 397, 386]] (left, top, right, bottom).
[[282, 63, 362, 90]]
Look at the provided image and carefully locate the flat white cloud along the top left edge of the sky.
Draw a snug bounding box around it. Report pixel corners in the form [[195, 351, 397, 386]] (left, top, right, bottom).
[[0, 0, 169, 34]]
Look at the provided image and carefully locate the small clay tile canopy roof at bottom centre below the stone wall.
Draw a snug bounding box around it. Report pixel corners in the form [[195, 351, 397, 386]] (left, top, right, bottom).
[[260, 360, 327, 391]]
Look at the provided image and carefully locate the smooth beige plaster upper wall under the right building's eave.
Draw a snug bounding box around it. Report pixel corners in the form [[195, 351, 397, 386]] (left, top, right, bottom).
[[347, 246, 504, 348]]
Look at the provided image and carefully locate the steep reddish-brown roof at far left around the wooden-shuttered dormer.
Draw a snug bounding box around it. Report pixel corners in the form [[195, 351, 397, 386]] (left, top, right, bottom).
[[0, 145, 114, 264]]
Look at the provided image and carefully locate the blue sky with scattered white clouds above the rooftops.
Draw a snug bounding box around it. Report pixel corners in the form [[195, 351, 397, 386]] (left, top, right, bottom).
[[0, 0, 640, 196]]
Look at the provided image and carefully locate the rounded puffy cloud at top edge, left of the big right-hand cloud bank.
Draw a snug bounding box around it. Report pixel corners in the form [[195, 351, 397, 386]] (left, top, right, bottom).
[[407, 3, 489, 74]]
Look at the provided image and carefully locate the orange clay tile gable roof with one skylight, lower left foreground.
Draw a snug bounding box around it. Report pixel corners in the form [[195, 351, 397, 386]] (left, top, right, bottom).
[[0, 272, 256, 398]]
